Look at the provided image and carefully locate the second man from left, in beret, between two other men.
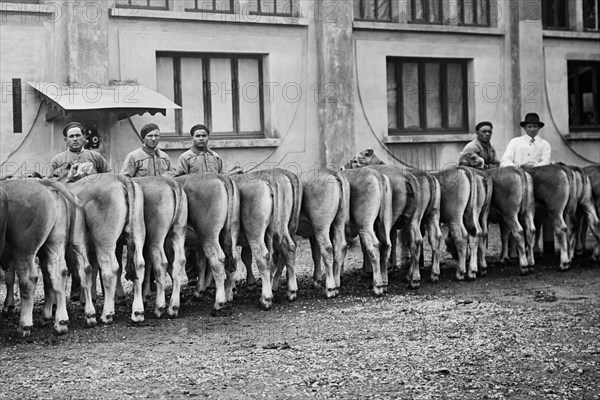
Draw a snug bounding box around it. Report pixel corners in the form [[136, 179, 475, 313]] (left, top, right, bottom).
[[121, 124, 171, 178]]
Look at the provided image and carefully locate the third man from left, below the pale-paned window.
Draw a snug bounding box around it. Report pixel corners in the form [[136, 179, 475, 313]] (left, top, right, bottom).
[[176, 124, 223, 176]]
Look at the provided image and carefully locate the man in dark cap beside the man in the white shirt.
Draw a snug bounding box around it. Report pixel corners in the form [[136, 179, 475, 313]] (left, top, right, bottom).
[[458, 121, 500, 169]]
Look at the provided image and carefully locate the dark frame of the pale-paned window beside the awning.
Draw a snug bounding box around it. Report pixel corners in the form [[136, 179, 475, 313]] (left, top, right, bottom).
[[156, 51, 266, 139]]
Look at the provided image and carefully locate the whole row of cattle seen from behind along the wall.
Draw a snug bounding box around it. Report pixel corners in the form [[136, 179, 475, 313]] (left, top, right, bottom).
[[0, 156, 600, 336]]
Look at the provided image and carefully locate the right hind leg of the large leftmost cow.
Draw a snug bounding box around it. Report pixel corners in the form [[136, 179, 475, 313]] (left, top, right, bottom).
[[42, 243, 69, 335]]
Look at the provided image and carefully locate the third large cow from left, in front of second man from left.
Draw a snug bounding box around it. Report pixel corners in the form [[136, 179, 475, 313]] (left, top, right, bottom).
[[132, 176, 188, 318]]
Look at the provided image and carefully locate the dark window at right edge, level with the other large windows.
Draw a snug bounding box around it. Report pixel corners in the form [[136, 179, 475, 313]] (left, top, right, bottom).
[[568, 61, 600, 130]]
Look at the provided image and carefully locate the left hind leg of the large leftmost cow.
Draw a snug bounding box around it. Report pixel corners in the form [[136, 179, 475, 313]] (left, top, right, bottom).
[[15, 253, 38, 337]]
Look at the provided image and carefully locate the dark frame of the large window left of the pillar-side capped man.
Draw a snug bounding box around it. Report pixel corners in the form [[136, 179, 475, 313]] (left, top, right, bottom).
[[386, 57, 469, 136]]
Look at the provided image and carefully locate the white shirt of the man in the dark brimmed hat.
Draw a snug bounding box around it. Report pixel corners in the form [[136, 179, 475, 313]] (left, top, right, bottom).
[[500, 135, 552, 167]]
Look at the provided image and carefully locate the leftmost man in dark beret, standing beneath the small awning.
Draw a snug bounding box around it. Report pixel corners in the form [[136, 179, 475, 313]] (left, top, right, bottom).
[[46, 122, 110, 177]]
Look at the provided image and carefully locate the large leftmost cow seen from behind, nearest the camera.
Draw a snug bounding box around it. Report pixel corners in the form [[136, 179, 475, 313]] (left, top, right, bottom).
[[1, 179, 82, 337]]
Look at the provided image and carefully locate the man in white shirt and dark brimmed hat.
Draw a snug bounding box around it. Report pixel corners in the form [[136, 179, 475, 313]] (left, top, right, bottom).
[[500, 113, 552, 167]]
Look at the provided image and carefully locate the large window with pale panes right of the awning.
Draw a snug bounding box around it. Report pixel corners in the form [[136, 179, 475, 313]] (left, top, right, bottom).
[[156, 53, 264, 137]]
